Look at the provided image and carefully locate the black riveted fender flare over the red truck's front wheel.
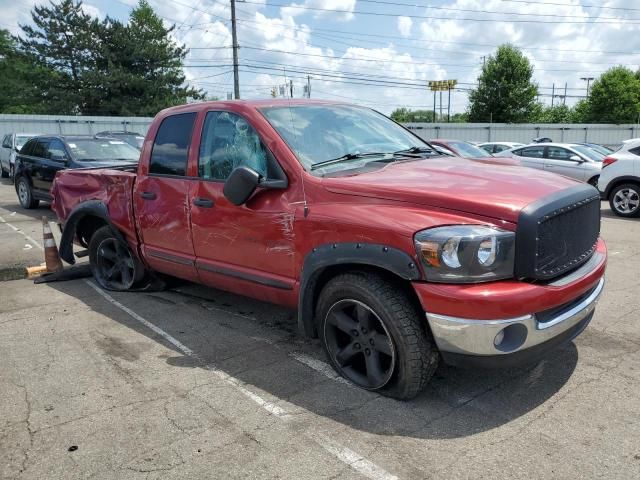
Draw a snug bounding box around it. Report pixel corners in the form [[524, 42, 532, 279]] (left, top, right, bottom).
[[298, 243, 422, 337]]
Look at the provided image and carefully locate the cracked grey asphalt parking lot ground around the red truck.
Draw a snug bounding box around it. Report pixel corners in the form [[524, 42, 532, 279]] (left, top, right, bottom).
[[0, 179, 640, 480]]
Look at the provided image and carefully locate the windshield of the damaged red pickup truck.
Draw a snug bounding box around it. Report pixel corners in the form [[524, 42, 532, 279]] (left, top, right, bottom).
[[261, 105, 429, 170]]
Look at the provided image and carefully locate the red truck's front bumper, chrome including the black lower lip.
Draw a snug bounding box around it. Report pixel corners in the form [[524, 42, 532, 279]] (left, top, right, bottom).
[[426, 278, 604, 367]]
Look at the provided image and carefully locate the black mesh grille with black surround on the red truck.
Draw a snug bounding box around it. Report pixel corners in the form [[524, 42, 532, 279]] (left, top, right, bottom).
[[516, 185, 600, 280]]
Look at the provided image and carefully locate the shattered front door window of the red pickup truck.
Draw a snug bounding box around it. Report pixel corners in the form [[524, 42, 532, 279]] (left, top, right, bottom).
[[198, 112, 268, 180]]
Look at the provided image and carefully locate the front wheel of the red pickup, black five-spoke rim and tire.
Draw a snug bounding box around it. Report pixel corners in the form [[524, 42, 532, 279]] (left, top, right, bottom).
[[316, 272, 440, 400]]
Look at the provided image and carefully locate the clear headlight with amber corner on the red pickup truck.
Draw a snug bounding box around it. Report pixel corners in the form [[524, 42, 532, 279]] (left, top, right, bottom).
[[415, 225, 516, 283]]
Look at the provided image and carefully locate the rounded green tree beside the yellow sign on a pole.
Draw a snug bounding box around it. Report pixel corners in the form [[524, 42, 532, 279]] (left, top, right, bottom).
[[468, 45, 538, 123]]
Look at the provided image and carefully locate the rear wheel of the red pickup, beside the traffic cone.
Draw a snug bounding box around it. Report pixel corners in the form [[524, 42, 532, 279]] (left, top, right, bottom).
[[89, 226, 145, 292]]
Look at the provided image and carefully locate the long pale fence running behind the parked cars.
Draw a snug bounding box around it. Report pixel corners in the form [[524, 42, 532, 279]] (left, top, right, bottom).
[[0, 115, 640, 146]]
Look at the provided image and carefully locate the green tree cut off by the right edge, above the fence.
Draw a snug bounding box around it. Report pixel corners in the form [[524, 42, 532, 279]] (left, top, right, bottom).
[[586, 67, 640, 123]]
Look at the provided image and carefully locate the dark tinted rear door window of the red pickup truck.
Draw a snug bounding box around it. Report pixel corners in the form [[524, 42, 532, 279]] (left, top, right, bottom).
[[149, 113, 196, 176]]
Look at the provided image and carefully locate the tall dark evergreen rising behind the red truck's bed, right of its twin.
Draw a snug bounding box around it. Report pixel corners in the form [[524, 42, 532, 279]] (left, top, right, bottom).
[[91, 0, 205, 116]]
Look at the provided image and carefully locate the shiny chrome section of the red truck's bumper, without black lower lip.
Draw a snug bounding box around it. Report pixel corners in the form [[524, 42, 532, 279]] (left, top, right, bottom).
[[427, 278, 604, 356]]
